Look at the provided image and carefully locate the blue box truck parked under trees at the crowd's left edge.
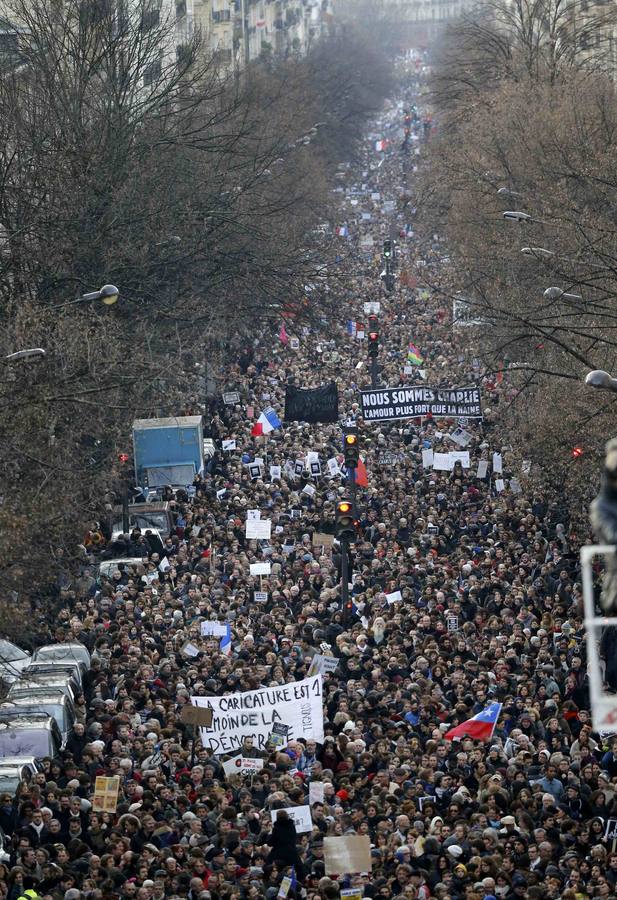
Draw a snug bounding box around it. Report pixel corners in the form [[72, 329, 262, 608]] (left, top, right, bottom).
[[133, 416, 204, 488]]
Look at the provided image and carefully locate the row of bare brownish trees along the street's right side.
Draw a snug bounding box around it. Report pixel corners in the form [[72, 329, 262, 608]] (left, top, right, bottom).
[[419, 0, 617, 536]]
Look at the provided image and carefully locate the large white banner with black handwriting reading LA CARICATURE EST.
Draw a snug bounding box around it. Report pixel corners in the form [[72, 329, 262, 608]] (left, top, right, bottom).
[[191, 674, 323, 756]]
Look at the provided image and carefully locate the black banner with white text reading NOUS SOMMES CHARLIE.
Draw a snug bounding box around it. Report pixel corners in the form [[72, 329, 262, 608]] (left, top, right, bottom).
[[361, 387, 482, 422]]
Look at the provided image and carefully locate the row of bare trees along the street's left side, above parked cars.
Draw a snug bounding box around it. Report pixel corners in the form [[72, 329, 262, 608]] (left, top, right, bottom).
[[0, 0, 392, 642]]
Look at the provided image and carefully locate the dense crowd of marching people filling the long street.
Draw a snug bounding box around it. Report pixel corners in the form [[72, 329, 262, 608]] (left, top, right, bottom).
[[0, 54, 617, 900]]
